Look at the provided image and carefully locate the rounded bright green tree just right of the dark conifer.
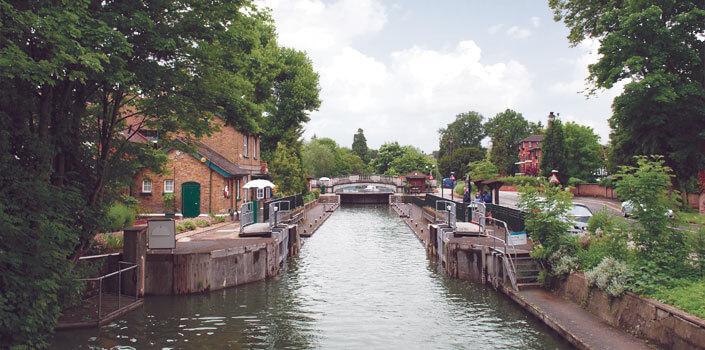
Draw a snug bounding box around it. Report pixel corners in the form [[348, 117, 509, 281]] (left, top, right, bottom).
[[563, 122, 605, 180]]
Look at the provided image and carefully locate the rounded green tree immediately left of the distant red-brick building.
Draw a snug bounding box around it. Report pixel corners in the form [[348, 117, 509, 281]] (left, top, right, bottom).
[[485, 109, 538, 175]]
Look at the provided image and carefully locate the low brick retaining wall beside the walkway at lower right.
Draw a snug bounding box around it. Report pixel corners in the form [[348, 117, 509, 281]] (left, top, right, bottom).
[[557, 273, 705, 349]]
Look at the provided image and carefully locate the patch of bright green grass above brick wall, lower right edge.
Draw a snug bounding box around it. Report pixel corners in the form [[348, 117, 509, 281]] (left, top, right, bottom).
[[653, 279, 705, 318]]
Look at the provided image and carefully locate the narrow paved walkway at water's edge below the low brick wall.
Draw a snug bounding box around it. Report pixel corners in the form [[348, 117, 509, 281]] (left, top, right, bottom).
[[510, 289, 655, 350]]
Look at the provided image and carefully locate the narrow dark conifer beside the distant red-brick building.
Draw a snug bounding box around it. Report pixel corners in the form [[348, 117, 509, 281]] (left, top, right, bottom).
[[541, 114, 568, 183]]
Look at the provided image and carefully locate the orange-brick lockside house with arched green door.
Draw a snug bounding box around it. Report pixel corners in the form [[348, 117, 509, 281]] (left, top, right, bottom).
[[128, 119, 270, 217]]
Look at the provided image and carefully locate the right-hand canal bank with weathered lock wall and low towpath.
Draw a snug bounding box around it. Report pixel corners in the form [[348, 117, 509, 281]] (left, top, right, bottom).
[[390, 196, 656, 349]]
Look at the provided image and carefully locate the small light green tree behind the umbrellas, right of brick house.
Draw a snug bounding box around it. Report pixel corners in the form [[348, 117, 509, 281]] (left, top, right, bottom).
[[270, 142, 306, 196]]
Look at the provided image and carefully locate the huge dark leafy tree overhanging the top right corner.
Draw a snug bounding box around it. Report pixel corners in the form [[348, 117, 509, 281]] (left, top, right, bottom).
[[549, 0, 705, 193]]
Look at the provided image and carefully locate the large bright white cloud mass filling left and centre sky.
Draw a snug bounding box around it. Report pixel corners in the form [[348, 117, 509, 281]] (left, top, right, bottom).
[[267, 0, 533, 152]]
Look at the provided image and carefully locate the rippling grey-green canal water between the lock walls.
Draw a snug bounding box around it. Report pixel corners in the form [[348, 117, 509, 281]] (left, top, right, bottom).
[[53, 206, 570, 349]]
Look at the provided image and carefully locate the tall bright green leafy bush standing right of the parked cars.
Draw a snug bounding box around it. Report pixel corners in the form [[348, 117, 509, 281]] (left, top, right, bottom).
[[616, 157, 675, 259]]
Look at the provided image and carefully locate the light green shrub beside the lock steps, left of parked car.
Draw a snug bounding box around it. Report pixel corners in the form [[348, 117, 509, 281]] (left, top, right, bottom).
[[518, 180, 573, 256]]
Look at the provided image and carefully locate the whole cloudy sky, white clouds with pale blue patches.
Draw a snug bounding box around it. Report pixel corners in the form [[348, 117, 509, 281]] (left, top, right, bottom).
[[263, 0, 618, 152]]
